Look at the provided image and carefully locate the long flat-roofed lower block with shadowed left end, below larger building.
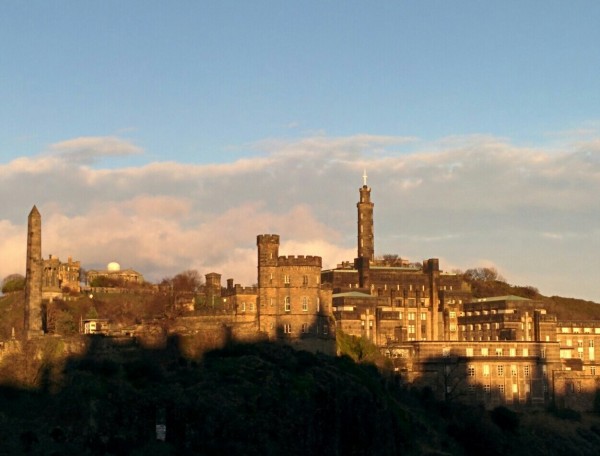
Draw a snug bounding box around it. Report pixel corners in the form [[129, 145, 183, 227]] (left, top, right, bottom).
[[384, 341, 561, 407]]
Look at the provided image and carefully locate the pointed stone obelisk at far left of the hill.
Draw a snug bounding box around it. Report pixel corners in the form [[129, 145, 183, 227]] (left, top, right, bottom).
[[24, 206, 44, 339]]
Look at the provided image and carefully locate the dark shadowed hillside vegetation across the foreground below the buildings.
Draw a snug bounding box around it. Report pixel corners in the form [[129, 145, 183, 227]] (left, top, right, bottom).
[[0, 338, 600, 456]]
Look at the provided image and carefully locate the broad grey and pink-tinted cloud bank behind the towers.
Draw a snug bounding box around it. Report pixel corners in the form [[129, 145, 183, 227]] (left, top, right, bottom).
[[0, 135, 600, 302]]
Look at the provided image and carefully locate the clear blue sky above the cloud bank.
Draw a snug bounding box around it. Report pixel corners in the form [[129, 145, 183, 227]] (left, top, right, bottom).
[[0, 1, 600, 162]]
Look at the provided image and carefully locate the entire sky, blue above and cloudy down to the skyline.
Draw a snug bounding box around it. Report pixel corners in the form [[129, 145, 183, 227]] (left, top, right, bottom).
[[0, 0, 600, 302]]
